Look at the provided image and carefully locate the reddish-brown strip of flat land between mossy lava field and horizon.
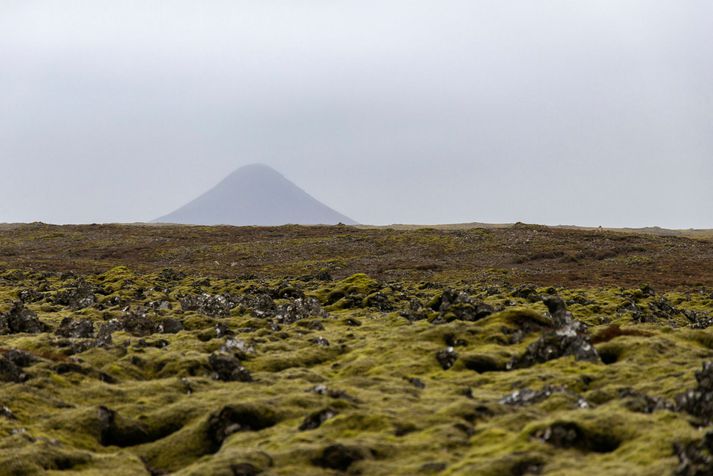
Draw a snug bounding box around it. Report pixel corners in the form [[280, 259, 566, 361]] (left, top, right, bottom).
[[0, 223, 713, 288]]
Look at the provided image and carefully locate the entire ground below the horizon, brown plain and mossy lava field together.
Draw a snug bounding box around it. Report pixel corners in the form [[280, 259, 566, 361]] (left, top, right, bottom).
[[0, 224, 713, 476]]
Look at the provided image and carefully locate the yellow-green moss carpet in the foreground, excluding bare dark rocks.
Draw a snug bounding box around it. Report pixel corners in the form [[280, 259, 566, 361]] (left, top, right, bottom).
[[0, 262, 713, 476]]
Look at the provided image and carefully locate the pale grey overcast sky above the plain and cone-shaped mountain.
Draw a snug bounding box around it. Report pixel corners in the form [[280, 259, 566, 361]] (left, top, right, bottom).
[[0, 0, 713, 228]]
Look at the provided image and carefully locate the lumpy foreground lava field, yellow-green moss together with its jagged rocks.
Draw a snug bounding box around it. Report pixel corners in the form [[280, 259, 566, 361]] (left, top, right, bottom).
[[0, 266, 713, 476]]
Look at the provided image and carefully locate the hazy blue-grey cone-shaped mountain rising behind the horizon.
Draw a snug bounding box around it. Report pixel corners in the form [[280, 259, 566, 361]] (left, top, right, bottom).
[[155, 164, 356, 226]]
